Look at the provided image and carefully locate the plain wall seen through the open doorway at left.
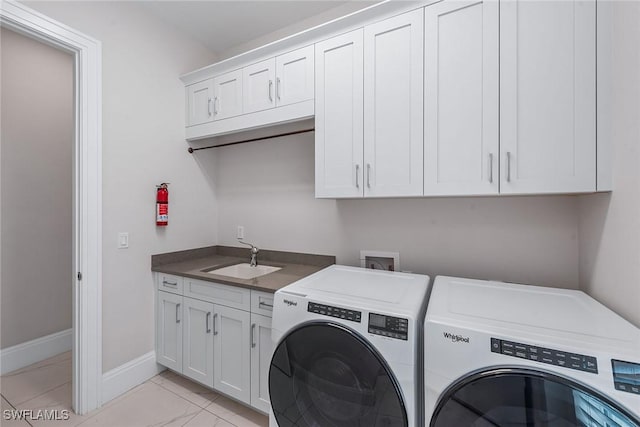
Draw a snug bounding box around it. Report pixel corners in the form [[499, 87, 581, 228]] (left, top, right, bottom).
[[0, 29, 74, 348]]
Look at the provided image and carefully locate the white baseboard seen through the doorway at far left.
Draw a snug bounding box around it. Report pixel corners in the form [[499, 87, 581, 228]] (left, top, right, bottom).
[[0, 329, 73, 375]]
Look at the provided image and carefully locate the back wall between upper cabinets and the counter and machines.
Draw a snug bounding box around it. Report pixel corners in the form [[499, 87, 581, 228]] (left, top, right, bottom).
[[214, 133, 578, 288]]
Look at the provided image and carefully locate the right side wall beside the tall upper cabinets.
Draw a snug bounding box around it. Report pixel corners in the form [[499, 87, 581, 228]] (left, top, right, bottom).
[[579, 1, 640, 327]]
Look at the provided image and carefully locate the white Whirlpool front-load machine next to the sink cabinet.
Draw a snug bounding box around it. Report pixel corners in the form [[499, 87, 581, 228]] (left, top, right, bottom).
[[269, 265, 429, 427]]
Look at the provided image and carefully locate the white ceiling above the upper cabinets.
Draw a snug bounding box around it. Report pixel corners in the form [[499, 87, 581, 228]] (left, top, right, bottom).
[[139, 0, 372, 55]]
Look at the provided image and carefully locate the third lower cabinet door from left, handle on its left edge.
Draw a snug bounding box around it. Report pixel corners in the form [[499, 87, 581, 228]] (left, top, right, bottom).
[[213, 305, 251, 403]]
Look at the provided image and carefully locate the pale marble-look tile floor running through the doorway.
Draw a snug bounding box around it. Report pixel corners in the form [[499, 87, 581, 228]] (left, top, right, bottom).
[[0, 352, 269, 427]]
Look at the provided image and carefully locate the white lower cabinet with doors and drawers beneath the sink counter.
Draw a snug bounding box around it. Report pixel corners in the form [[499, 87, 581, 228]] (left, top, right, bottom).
[[156, 274, 273, 413]]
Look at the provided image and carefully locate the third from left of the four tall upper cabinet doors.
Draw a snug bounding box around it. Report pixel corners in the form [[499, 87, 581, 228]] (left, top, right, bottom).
[[424, 0, 499, 195]]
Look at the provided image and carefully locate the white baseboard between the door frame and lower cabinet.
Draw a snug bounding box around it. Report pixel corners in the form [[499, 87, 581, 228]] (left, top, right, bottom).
[[102, 351, 166, 405]]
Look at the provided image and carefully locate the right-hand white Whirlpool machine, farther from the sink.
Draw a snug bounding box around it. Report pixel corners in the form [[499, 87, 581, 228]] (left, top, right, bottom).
[[425, 277, 640, 427]]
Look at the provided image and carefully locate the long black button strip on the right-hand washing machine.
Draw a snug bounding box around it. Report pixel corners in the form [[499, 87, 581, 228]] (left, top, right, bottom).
[[491, 338, 598, 374]]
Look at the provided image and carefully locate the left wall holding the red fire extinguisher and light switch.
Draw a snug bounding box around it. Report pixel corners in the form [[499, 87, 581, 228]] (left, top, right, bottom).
[[25, 2, 217, 371]]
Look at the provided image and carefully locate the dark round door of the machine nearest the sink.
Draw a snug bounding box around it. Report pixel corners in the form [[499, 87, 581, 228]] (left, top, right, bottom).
[[269, 322, 408, 427]]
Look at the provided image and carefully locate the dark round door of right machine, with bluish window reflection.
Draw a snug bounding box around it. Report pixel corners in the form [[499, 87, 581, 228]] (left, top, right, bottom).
[[429, 368, 640, 427]]
